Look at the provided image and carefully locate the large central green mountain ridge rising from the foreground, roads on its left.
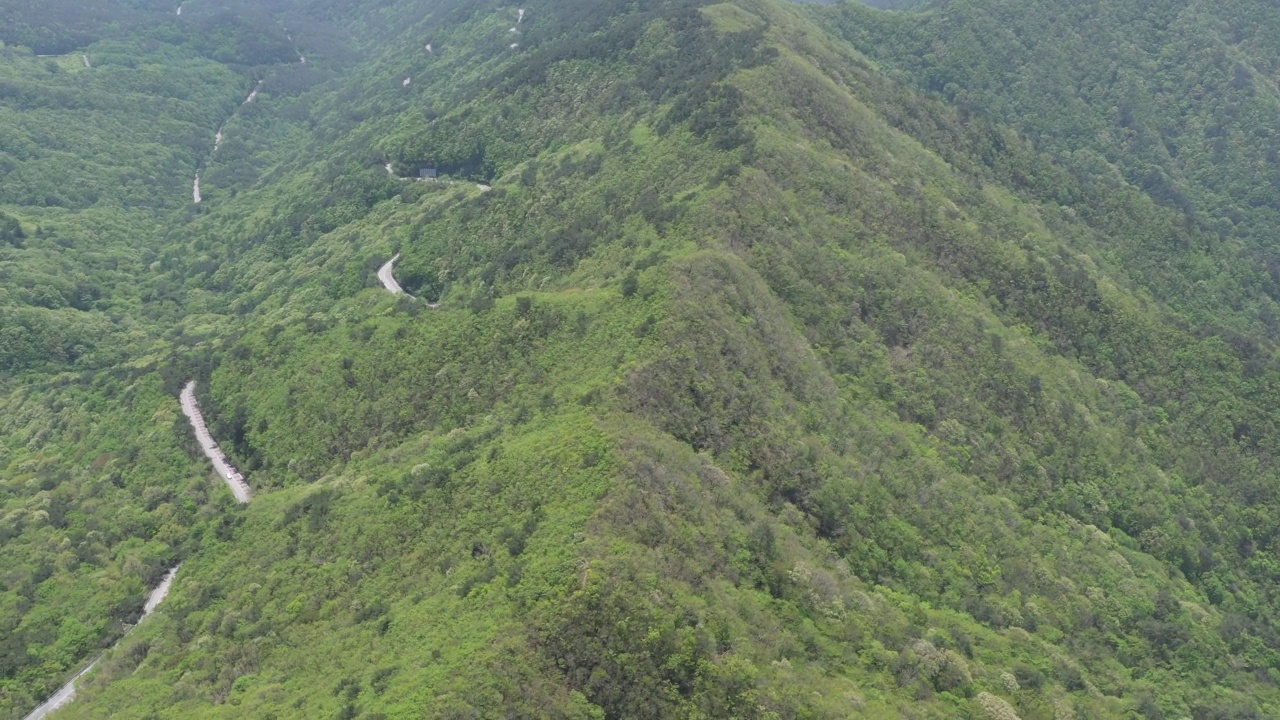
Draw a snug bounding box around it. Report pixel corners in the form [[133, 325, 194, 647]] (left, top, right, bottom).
[[7, 0, 1280, 717]]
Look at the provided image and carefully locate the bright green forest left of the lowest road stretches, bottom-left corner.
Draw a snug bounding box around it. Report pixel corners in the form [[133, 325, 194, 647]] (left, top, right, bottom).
[[0, 373, 233, 714]]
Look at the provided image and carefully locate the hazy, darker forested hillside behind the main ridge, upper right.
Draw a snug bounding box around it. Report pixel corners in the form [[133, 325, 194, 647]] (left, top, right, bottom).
[[823, 0, 1280, 337]]
